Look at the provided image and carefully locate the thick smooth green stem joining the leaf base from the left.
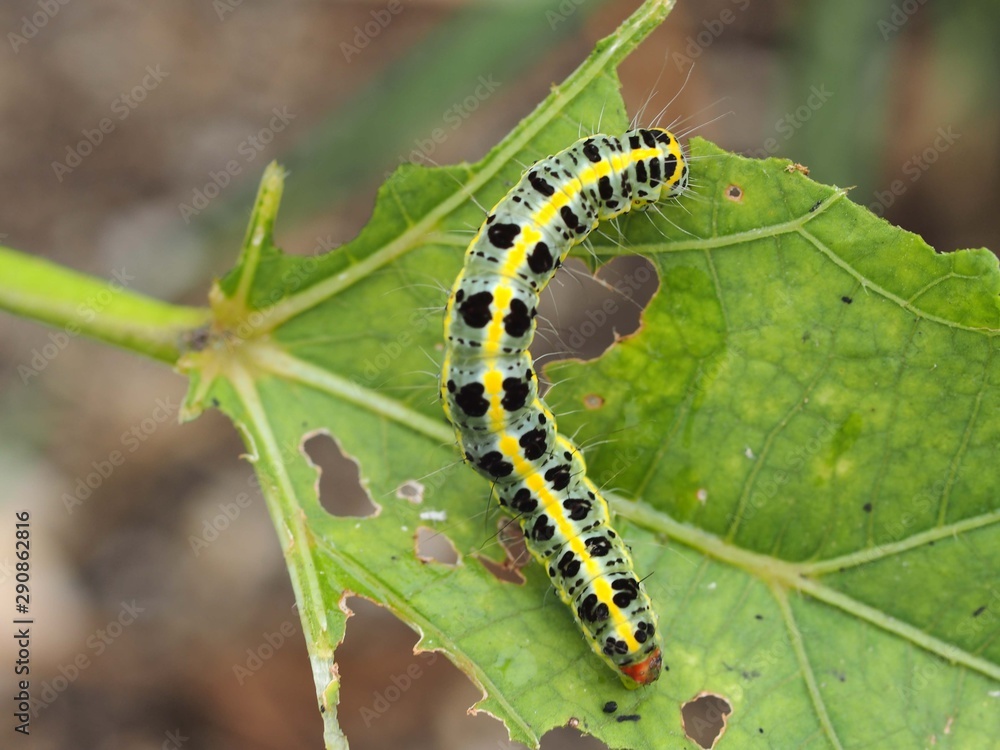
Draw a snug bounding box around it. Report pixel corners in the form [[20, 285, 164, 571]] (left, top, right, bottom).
[[0, 247, 210, 364]]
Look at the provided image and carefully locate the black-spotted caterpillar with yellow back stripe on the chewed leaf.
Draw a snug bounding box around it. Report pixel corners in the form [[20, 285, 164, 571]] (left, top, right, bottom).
[[440, 128, 688, 688]]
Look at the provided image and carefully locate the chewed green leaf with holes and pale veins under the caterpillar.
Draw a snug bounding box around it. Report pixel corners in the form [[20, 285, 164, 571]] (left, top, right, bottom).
[[181, 2, 1000, 748]]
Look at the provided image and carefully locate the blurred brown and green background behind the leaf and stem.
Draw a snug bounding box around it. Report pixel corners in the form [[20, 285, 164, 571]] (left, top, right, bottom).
[[0, 0, 1000, 750]]
